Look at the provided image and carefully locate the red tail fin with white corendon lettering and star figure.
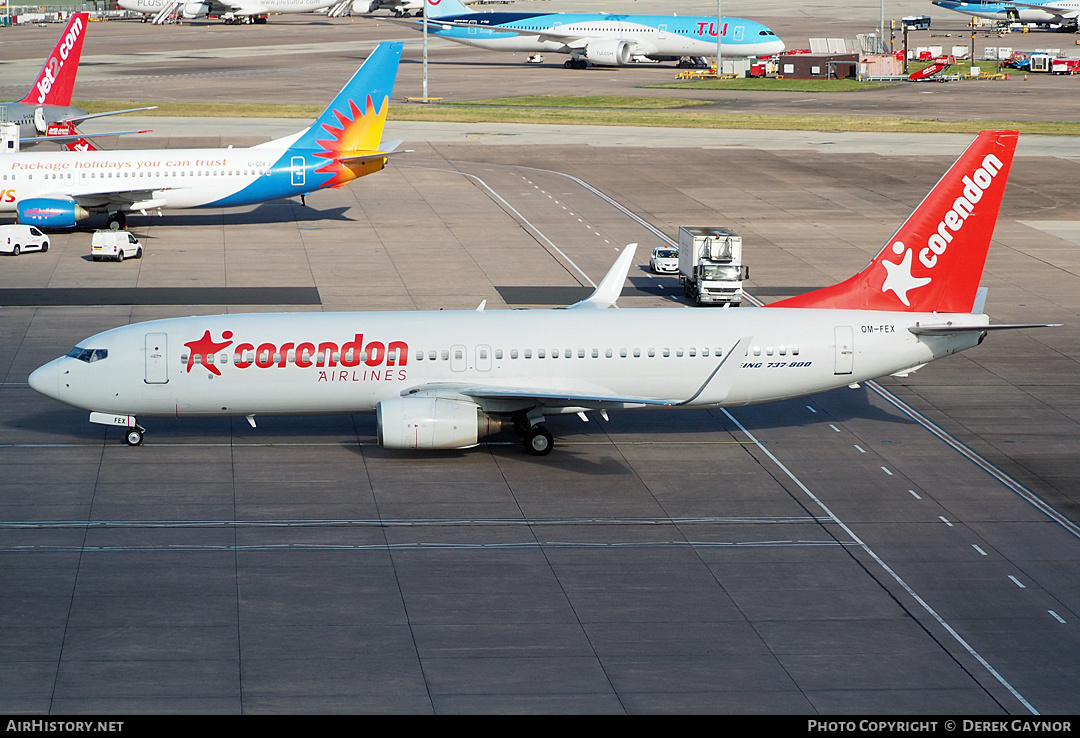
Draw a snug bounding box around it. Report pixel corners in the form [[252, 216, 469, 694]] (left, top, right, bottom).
[[768, 131, 1018, 312]]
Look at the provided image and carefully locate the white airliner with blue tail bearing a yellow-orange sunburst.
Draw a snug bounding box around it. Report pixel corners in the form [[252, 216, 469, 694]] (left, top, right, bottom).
[[0, 42, 402, 228]]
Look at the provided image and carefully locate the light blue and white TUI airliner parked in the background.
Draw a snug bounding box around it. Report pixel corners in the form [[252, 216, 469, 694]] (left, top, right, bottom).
[[391, 0, 784, 69]]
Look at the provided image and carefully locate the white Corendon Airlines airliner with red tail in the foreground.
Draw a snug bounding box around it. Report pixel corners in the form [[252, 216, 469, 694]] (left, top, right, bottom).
[[29, 131, 1054, 455]]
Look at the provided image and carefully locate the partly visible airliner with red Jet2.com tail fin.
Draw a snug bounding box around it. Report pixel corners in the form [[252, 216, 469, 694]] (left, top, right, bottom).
[[0, 13, 152, 145]]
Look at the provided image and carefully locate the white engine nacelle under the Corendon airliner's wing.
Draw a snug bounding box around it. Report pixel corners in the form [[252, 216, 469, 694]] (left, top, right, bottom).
[[376, 398, 502, 448]]
